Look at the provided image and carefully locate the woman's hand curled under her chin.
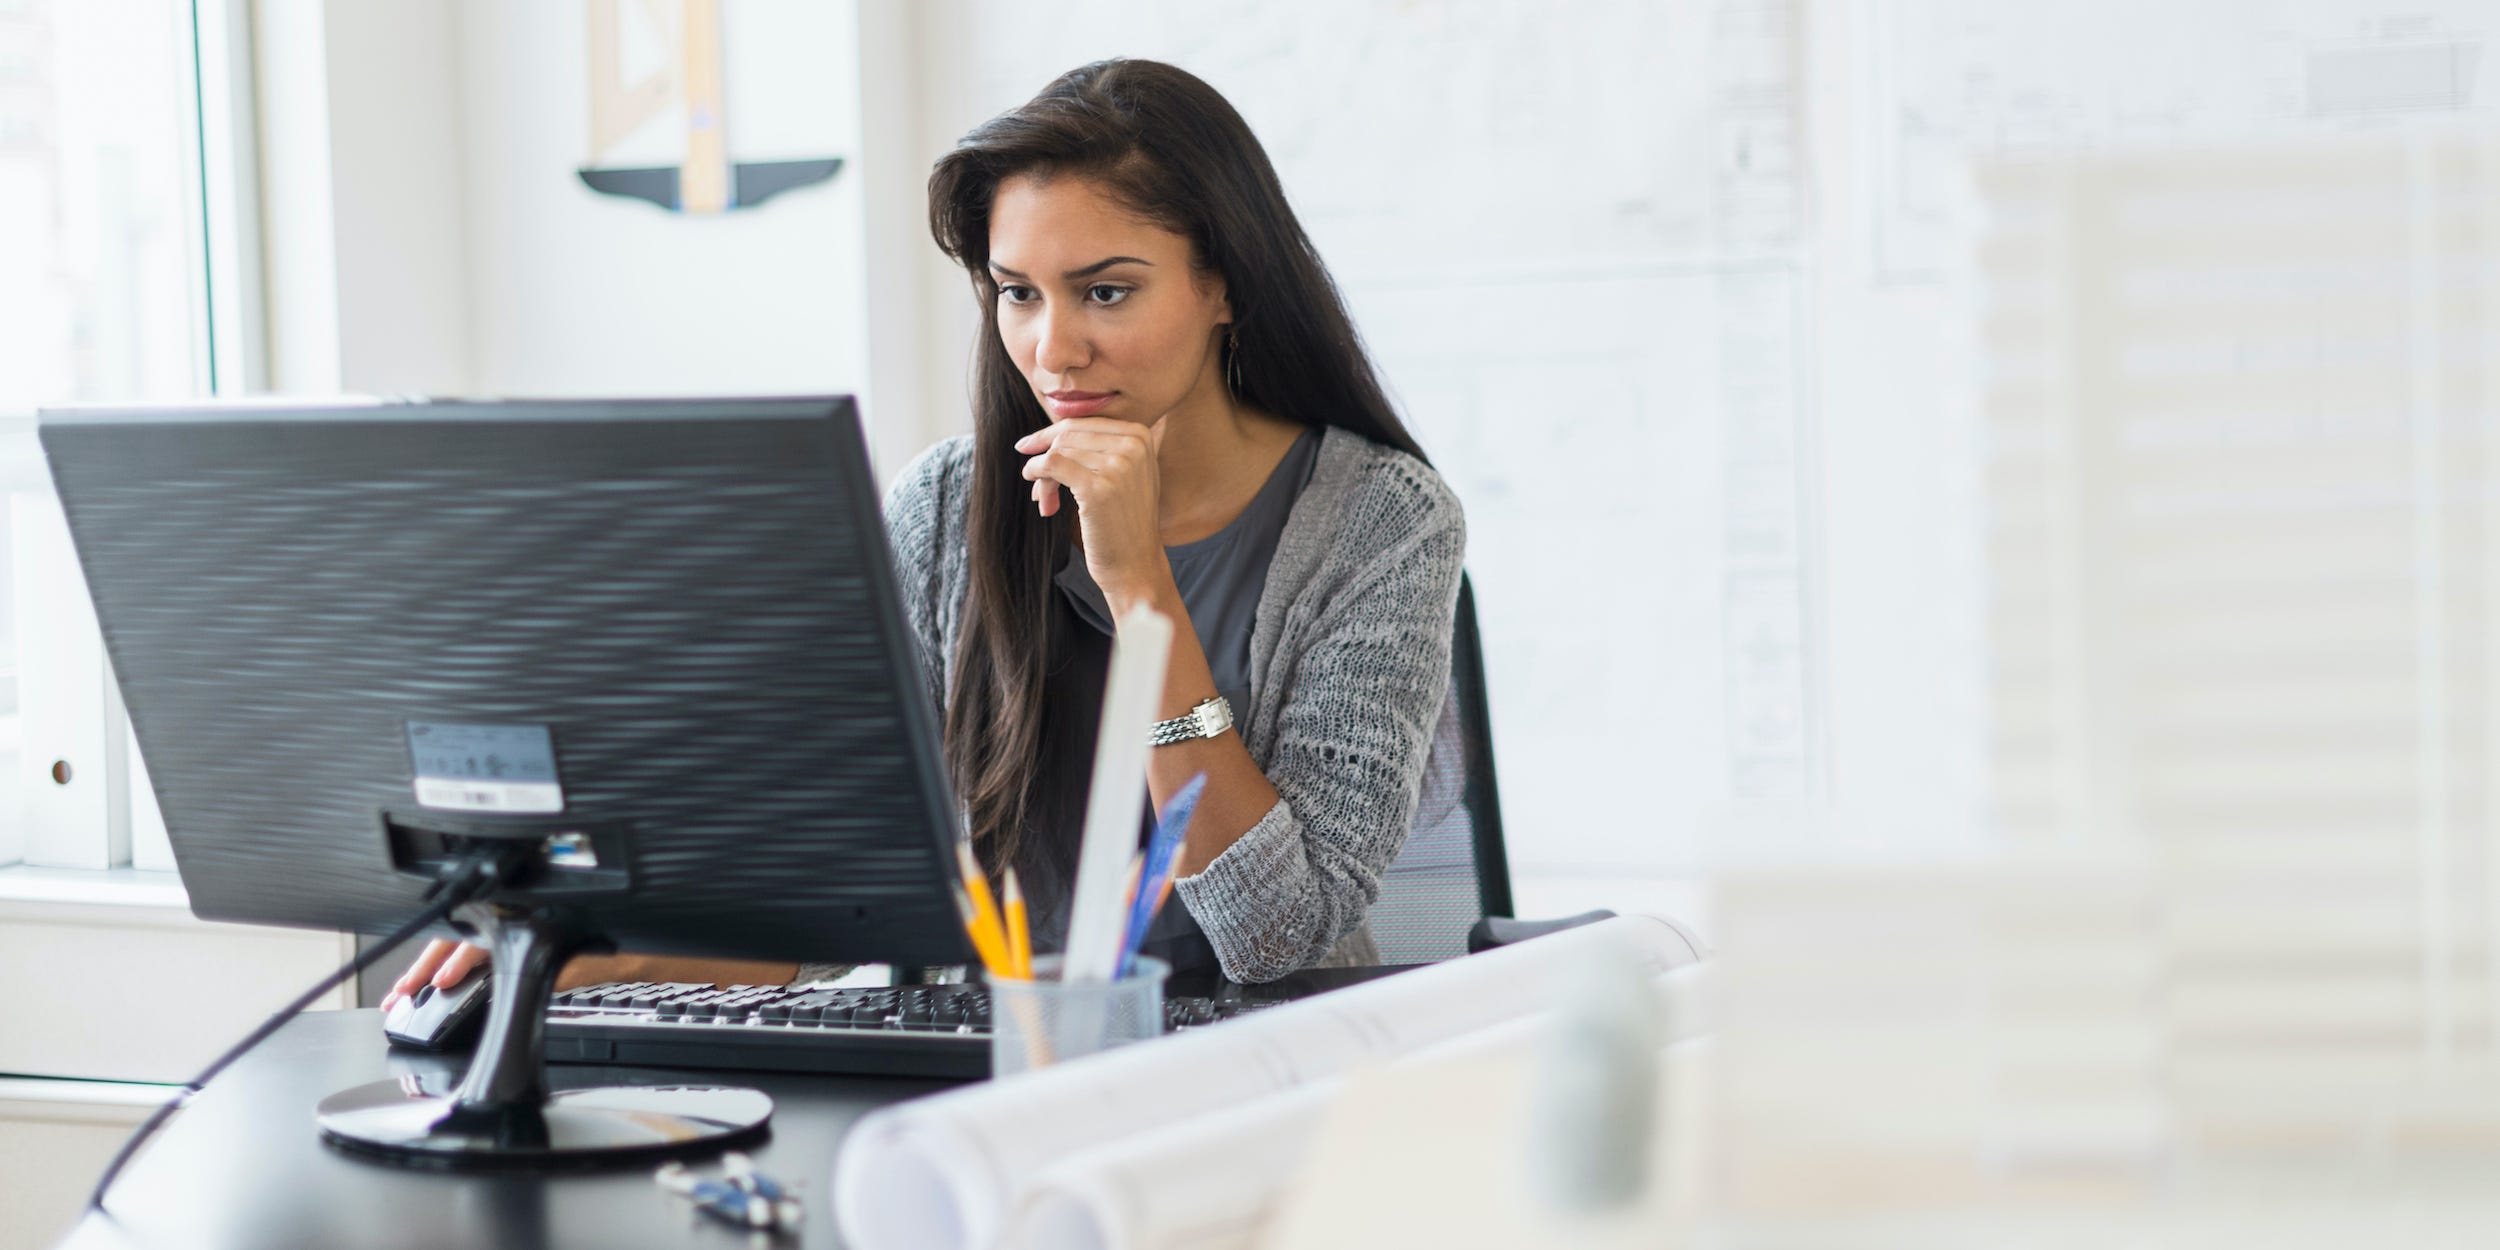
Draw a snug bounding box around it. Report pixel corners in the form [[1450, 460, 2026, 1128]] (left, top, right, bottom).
[[1015, 418, 1170, 610]]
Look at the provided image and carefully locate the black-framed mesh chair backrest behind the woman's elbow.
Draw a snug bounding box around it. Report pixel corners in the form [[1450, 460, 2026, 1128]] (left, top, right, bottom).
[[1368, 575, 1510, 963]]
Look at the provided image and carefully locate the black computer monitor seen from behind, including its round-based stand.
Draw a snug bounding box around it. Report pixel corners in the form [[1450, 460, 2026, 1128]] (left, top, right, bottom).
[[40, 398, 970, 1163]]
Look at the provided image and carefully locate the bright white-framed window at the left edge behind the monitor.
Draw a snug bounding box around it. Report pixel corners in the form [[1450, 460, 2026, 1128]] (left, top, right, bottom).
[[0, 0, 235, 868]]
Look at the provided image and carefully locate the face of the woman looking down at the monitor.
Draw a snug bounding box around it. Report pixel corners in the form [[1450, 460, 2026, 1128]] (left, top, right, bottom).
[[990, 175, 1233, 423]]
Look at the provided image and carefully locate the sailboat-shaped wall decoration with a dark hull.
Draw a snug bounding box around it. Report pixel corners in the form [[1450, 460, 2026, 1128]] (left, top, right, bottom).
[[578, 0, 843, 215]]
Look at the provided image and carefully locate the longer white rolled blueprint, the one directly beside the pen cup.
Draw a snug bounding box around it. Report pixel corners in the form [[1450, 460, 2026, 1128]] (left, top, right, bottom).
[[833, 915, 1700, 1250]]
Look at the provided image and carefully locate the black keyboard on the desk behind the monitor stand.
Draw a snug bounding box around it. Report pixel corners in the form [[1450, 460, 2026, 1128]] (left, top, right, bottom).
[[548, 983, 1283, 1078]]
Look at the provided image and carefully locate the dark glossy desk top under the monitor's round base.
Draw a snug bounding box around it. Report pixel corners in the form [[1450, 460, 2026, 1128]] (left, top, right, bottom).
[[60, 968, 1390, 1250]]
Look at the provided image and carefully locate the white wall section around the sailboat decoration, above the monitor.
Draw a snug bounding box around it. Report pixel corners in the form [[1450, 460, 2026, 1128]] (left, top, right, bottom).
[[258, 0, 918, 468]]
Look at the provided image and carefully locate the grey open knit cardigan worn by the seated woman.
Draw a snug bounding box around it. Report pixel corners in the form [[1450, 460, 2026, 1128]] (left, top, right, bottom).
[[885, 428, 1468, 983]]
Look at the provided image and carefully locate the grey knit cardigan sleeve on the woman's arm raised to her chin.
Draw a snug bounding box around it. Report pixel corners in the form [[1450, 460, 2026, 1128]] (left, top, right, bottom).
[[1175, 465, 1468, 983]]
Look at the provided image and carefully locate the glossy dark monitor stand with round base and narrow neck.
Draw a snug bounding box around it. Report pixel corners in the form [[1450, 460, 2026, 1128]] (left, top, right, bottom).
[[315, 903, 773, 1168]]
